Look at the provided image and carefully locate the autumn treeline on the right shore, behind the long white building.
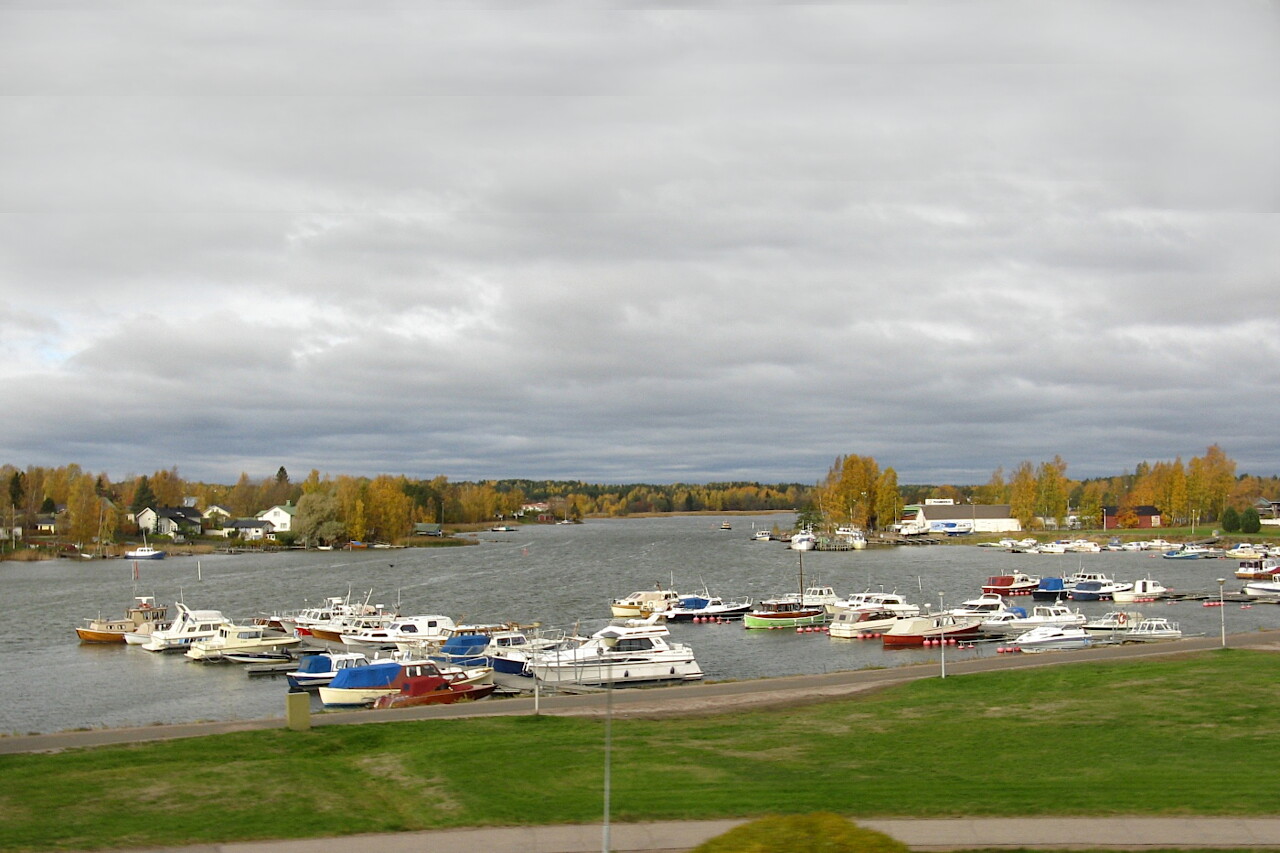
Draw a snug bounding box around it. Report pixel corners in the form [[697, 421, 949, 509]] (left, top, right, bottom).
[[813, 444, 1280, 529]]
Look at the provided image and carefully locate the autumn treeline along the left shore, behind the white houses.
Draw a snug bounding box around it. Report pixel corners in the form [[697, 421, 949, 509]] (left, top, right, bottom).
[[0, 464, 810, 543]]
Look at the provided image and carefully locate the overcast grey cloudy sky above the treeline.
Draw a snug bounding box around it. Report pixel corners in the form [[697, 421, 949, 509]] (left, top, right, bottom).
[[0, 0, 1280, 484]]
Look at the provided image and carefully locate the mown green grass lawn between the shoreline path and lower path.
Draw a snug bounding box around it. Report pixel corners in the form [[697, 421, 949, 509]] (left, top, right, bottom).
[[0, 649, 1280, 850]]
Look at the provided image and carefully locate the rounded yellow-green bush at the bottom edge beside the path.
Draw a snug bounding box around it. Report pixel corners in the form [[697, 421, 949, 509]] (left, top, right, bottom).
[[692, 812, 908, 853]]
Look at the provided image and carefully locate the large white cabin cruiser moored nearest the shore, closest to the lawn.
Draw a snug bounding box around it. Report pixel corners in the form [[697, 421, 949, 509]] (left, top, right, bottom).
[[529, 617, 703, 686]]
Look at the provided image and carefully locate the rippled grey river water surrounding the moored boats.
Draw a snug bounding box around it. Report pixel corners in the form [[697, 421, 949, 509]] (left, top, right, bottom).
[[0, 515, 1280, 734]]
